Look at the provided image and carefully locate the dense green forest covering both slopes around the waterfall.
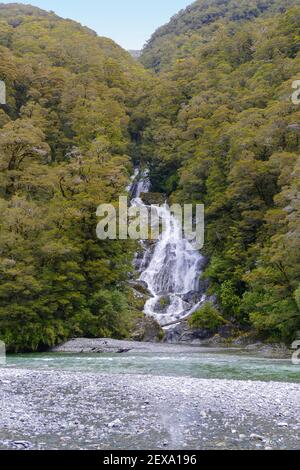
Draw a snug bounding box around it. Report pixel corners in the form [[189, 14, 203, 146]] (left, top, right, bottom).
[[0, 0, 300, 351]]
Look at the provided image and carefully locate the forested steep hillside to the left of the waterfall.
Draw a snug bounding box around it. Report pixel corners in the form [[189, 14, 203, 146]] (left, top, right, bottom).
[[0, 4, 149, 350]]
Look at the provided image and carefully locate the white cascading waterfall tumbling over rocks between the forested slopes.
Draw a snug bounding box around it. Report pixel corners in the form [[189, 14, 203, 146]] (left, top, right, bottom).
[[132, 171, 205, 326]]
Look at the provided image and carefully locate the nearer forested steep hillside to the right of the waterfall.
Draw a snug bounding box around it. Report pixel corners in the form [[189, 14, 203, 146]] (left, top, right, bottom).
[[141, 1, 300, 340]]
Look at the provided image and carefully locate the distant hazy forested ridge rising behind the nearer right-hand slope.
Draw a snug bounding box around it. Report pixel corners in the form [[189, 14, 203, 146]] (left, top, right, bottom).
[[141, 0, 299, 72]]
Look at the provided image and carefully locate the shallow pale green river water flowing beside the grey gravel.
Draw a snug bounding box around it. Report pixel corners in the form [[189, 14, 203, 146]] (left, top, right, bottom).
[[6, 350, 300, 383]]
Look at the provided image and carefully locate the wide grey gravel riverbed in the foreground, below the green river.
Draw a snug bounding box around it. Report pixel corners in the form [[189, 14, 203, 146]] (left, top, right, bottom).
[[0, 368, 300, 450]]
